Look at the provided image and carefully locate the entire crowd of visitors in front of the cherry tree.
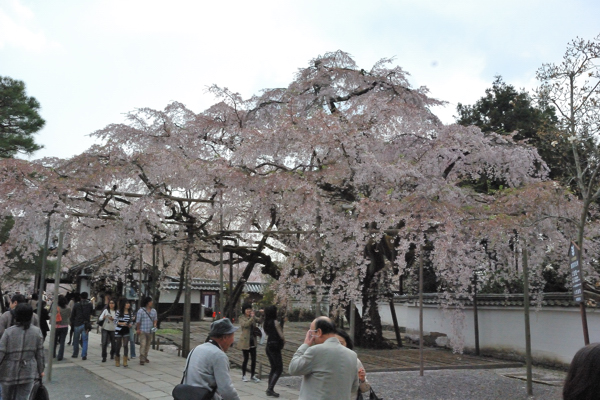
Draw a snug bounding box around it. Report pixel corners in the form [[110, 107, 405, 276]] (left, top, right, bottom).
[[0, 292, 600, 400]]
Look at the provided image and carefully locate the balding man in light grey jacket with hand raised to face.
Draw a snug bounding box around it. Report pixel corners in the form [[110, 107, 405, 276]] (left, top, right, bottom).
[[289, 317, 359, 400]]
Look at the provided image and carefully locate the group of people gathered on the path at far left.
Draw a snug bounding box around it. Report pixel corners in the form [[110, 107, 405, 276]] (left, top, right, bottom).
[[0, 292, 158, 400]]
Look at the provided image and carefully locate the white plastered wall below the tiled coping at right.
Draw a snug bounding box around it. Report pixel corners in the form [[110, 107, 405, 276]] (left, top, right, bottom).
[[358, 303, 600, 365]]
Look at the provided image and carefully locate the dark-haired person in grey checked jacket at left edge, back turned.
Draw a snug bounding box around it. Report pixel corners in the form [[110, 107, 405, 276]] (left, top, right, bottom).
[[0, 302, 44, 400]]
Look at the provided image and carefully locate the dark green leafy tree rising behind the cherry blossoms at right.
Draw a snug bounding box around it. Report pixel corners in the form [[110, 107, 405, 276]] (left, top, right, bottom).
[[455, 76, 572, 181]]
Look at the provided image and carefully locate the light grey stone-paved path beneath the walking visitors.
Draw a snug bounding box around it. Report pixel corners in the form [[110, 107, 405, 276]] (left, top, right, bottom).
[[54, 331, 299, 400]]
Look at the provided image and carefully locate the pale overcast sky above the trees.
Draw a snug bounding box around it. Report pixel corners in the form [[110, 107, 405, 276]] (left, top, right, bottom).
[[0, 0, 600, 158]]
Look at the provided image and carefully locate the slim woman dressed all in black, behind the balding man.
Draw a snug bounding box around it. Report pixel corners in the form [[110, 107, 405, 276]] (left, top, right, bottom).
[[263, 306, 285, 397]]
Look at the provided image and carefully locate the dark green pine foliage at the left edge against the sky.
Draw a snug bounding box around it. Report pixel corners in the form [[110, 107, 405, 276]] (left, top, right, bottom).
[[0, 76, 46, 158]]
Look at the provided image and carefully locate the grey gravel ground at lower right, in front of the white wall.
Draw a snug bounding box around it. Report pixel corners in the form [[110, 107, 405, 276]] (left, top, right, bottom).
[[278, 370, 562, 400]]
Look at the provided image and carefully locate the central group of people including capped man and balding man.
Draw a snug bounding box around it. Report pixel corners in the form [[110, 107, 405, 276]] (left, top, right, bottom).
[[182, 304, 371, 400]]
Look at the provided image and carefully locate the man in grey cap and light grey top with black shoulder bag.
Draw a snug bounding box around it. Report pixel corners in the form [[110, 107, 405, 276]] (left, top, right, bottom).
[[183, 318, 240, 400]]
